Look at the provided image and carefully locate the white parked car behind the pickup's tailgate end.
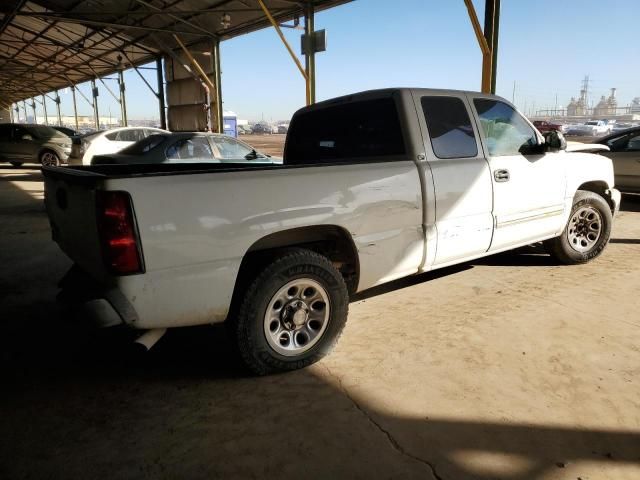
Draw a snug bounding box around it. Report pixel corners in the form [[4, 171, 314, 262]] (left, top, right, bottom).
[[68, 127, 169, 165]]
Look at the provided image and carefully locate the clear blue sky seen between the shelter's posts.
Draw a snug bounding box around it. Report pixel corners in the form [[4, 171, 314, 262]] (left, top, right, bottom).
[[22, 0, 640, 124]]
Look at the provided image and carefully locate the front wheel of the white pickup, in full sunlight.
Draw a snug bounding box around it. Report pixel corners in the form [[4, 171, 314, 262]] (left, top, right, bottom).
[[544, 190, 613, 265]]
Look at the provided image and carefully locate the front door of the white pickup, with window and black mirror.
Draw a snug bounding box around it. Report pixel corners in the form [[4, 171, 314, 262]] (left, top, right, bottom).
[[472, 96, 566, 251]]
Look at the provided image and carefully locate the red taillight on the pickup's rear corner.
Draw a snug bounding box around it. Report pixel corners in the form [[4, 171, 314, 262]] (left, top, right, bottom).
[[96, 191, 143, 275]]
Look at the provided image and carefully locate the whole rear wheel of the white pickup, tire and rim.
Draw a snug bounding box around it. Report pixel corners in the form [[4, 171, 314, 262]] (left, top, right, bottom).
[[230, 249, 349, 375]]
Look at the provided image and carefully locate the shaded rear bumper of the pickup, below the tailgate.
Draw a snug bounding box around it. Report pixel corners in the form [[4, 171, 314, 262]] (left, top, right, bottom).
[[58, 265, 138, 328]]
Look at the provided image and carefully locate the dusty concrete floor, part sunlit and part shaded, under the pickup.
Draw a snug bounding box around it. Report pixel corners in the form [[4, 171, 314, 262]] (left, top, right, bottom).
[[0, 159, 640, 480]]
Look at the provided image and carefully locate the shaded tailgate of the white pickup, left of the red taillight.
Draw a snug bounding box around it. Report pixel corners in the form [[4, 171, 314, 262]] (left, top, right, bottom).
[[42, 167, 106, 279]]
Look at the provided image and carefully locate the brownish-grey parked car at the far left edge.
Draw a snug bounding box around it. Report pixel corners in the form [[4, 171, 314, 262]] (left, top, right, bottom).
[[0, 123, 71, 167]]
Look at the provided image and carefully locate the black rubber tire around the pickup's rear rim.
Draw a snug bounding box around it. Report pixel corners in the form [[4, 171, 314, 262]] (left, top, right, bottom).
[[229, 249, 349, 375]]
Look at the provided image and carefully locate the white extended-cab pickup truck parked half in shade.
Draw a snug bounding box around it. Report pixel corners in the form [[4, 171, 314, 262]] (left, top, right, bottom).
[[43, 89, 620, 374]]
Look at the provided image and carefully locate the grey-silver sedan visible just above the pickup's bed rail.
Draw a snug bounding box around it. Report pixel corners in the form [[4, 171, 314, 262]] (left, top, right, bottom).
[[91, 132, 282, 165]]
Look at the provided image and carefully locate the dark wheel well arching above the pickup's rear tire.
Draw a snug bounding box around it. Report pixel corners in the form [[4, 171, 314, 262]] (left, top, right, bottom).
[[231, 225, 360, 318]]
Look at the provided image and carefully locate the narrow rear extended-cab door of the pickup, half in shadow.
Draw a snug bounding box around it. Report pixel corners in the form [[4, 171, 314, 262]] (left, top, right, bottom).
[[414, 90, 493, 268]]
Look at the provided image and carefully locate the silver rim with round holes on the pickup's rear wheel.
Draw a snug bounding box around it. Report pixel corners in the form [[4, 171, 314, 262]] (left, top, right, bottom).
[[264, 278, 330, 357]]
